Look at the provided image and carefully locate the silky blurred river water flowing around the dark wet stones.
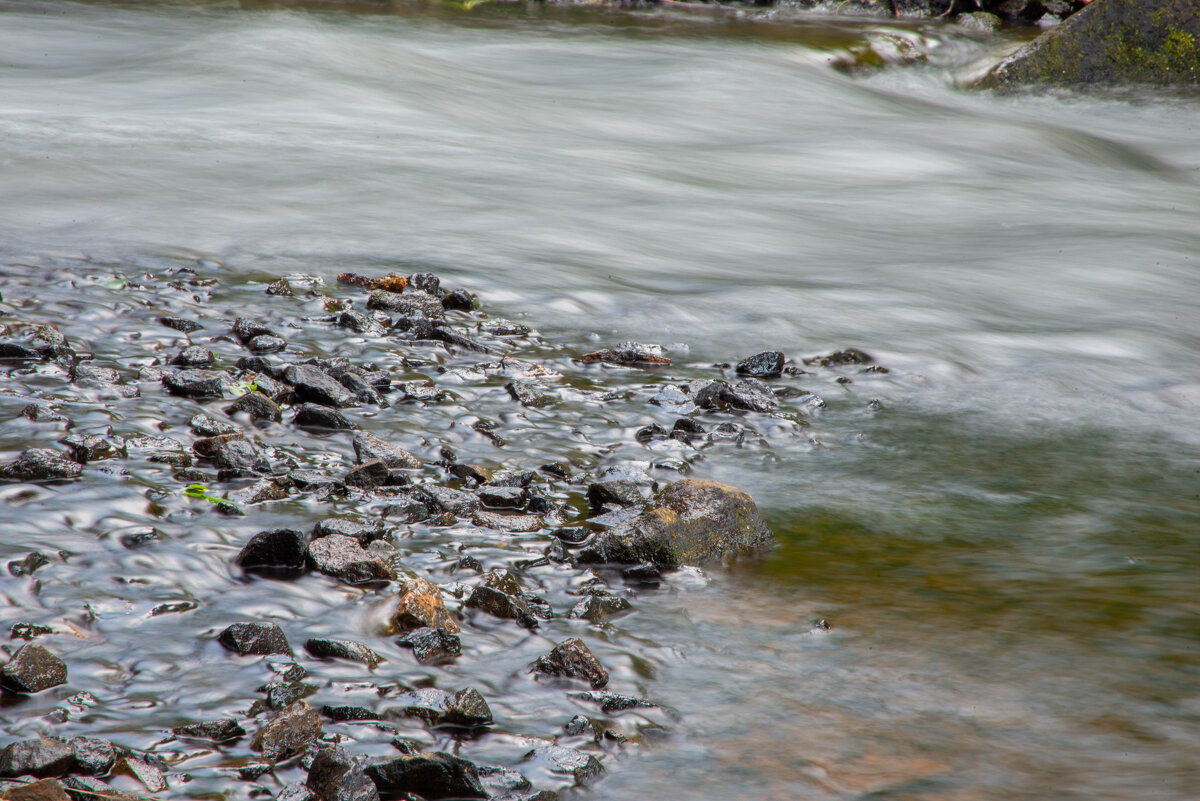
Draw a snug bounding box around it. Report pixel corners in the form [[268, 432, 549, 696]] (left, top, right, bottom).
[[0, 0, 1200, 801]]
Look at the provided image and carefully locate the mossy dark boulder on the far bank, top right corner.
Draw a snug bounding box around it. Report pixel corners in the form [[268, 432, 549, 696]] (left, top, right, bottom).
[[980, 0, 1200, 89]]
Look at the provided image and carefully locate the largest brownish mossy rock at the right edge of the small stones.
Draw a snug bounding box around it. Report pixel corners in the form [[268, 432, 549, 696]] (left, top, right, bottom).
[[578, 478, 774, 568]]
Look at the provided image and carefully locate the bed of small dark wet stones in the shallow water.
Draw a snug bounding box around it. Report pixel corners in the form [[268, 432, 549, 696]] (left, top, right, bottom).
[[0, 269, 887, 801]]
